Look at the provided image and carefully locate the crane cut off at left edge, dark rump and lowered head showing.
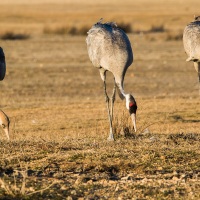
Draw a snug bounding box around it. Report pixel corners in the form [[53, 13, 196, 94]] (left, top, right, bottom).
[[0, 47, 10, 140]]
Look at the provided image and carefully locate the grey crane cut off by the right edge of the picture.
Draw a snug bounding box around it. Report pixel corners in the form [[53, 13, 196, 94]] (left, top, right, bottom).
[[183, 16, 200, 94]]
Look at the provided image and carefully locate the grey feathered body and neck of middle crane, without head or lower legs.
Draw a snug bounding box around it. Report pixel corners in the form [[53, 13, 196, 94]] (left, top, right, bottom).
[[86, 19, 133, 99]]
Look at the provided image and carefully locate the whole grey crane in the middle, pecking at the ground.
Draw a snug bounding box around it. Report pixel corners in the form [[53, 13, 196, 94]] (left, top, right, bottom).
[[86, 20, 137, 140]]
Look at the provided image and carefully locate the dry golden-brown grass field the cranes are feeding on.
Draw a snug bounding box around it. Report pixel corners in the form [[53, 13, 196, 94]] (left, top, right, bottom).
[[0, 0, 200, 200]]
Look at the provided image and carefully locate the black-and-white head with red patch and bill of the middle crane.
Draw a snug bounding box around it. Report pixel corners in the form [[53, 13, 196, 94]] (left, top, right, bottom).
[[125, 94, 137, 132]]
